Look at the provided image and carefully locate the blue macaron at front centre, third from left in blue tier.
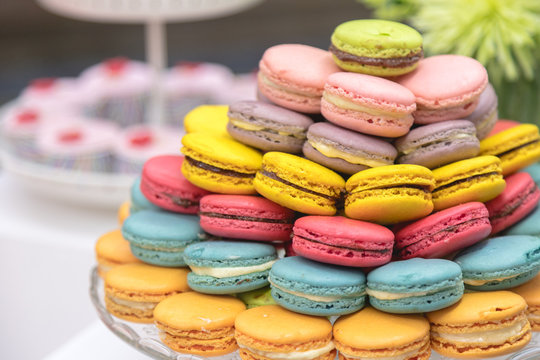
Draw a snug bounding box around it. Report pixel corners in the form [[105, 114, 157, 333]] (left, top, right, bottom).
[[269, 256, 366, 316]]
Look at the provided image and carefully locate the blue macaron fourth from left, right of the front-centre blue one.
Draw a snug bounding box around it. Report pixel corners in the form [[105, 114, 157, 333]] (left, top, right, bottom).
[[367, 258, 464, 314]]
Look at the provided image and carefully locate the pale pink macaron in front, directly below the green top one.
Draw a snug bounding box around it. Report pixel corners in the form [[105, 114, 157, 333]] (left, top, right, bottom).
[[321, 72, 416, 137]]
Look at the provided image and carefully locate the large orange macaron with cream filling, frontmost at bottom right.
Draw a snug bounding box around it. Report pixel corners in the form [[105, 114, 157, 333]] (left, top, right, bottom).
[[426, 291, 531, 359]]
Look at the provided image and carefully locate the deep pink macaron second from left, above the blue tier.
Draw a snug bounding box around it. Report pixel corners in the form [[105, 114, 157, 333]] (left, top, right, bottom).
[[199, 194, 294, 242]]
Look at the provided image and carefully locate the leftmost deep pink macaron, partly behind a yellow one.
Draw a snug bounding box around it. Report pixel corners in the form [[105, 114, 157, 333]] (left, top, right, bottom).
[[141, 155, 210, 214]]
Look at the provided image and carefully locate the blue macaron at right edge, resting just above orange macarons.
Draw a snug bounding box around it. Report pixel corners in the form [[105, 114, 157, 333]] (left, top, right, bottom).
[[454, 235, 540, 291]]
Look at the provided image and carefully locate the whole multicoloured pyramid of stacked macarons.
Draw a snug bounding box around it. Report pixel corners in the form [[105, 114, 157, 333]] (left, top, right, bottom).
[[96, 20, 540, 360]]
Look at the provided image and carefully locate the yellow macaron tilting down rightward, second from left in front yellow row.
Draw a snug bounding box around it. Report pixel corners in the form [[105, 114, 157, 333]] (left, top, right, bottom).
[[253, 151, 345, 215]]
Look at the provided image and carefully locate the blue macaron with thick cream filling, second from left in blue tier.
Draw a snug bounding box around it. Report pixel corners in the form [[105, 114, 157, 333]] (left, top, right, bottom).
[[184, 241, 277, 294]]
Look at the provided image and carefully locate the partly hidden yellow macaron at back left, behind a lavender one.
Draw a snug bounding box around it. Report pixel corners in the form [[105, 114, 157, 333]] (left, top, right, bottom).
[[184, 105, 231, 139]]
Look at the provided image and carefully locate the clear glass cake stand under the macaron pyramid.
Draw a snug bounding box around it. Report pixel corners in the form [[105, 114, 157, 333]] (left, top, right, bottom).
[[90, 267, 540, 360]]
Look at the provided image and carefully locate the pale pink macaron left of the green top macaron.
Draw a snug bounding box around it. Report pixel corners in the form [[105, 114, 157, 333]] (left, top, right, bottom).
[[257, 44, 340, 114]]
